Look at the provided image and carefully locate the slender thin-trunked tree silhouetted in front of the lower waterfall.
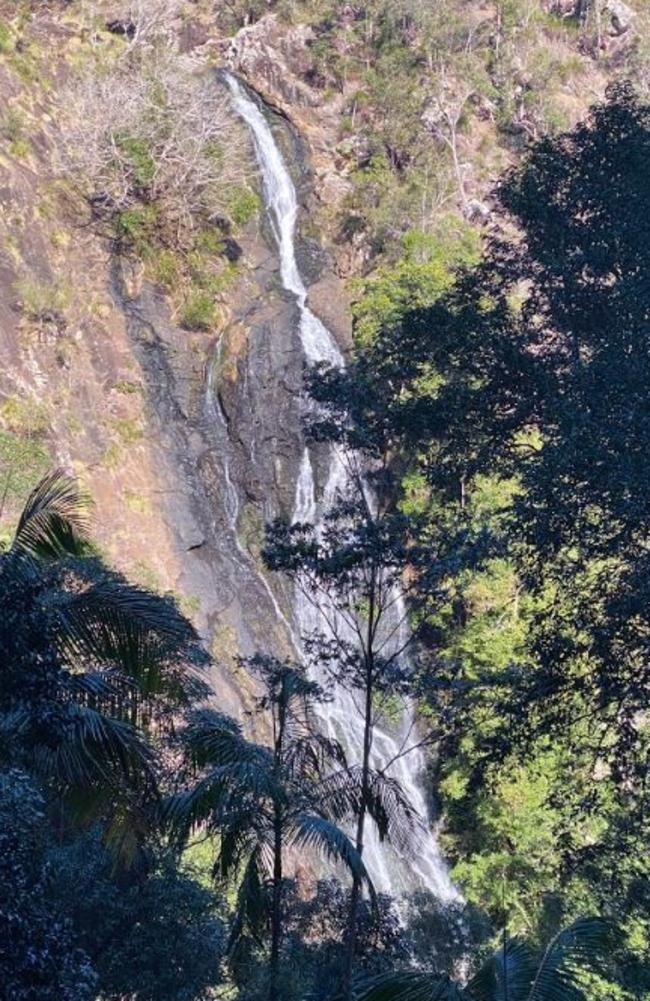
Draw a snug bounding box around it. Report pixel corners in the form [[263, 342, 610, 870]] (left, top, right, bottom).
[[264, 442, 478, 997]]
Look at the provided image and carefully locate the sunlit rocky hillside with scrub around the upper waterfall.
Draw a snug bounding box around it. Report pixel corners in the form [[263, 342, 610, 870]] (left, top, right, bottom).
[[0, 0, 649, 688]]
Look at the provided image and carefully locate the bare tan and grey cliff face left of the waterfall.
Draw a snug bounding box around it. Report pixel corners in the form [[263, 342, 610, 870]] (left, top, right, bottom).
[[0, 5, 349, 712]]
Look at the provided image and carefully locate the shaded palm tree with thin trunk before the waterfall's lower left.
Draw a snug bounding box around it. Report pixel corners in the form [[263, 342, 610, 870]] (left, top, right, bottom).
[[168, 655, 374, 1001]]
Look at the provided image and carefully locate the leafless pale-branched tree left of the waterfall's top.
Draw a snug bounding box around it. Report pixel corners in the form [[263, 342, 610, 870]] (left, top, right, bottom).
[[60, 0, 249, 238]]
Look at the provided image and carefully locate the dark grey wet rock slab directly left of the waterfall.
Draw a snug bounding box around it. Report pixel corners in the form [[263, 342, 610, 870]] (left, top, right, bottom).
[[109, 101, 348, 696]]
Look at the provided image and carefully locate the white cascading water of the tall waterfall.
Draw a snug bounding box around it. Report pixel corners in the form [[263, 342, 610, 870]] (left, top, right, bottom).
[[224, 73, 459, 901]]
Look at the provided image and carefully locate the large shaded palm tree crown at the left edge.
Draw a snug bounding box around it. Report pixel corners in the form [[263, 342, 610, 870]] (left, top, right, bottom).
[[0, 470, 205, 850]]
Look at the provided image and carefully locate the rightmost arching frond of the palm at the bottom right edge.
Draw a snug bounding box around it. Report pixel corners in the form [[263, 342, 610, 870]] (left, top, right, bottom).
[[527, 917, 616, 1001]]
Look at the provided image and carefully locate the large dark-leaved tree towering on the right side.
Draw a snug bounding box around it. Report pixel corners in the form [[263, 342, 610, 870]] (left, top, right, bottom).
[[324, 85, 650, 840]]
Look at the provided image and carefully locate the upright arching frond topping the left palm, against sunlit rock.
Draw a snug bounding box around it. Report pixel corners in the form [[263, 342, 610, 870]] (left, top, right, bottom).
[[11, 469, 90, 560]]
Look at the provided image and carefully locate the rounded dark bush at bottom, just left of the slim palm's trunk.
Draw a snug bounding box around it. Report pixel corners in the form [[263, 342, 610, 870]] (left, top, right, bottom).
[[48, 832, 225, 1001]]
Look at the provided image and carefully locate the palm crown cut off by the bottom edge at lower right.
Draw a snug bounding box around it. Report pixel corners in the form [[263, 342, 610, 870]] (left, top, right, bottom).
[[355, 918, 614, 1001]]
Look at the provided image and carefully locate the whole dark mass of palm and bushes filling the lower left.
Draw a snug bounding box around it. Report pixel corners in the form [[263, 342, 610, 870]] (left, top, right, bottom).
[[0, 471, 230, 1001]]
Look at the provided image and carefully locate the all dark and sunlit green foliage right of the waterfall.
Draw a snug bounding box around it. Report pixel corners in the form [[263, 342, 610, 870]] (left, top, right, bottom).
[[305, 86, 650, 984]]
